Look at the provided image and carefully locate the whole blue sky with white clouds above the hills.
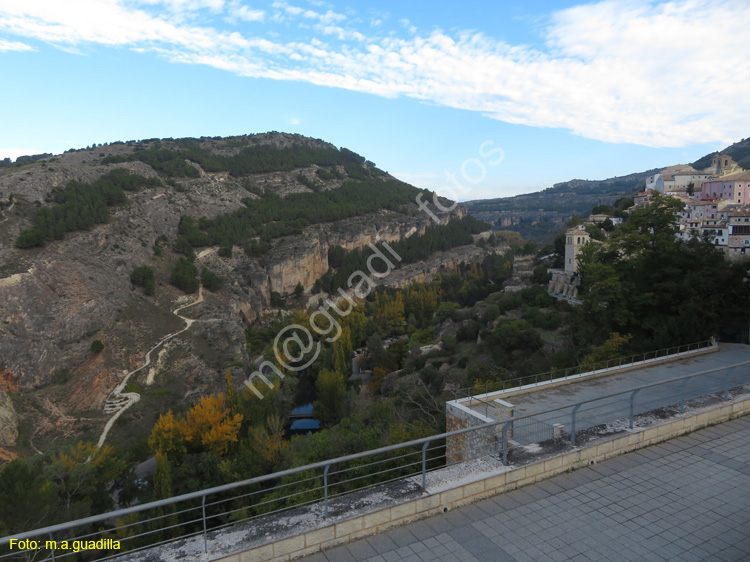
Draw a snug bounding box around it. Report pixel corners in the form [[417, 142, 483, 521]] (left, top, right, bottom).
[[0, 0, 750, 200]]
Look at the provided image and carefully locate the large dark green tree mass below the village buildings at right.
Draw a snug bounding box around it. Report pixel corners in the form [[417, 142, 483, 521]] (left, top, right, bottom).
[[578, 195, 745, 351]]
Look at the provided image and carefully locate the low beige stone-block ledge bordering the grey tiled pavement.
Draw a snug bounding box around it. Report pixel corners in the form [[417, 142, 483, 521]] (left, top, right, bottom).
[[214, 390, 750, 562]]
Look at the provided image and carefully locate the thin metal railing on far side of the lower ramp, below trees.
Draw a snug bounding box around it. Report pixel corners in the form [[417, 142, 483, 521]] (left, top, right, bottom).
[[453, 338, 716, 400]]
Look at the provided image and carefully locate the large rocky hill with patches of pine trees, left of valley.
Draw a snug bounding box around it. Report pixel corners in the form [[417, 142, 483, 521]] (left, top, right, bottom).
[[0, 133, 488, 476]]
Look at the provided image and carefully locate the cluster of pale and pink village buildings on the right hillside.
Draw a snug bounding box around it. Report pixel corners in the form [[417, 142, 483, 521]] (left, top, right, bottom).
[[548, 154, 750, 304]]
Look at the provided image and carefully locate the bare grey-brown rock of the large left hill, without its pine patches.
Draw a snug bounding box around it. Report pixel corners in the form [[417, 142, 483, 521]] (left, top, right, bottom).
[[0, 135, 483, 452]]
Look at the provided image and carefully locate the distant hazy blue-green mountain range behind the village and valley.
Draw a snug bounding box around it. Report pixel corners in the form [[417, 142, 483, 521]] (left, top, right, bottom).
[[464, 138, 750, 242]]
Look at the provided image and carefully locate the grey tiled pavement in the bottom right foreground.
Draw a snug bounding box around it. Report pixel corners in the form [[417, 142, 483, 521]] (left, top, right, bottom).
[[302, 416, 750, 562]]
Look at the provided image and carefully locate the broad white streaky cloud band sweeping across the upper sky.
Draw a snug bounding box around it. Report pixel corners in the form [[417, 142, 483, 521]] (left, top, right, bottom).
[[0, 0, 750, 146]]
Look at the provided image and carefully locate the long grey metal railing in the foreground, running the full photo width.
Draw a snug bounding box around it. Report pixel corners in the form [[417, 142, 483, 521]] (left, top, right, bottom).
[[0, 350, 750, 561]]
